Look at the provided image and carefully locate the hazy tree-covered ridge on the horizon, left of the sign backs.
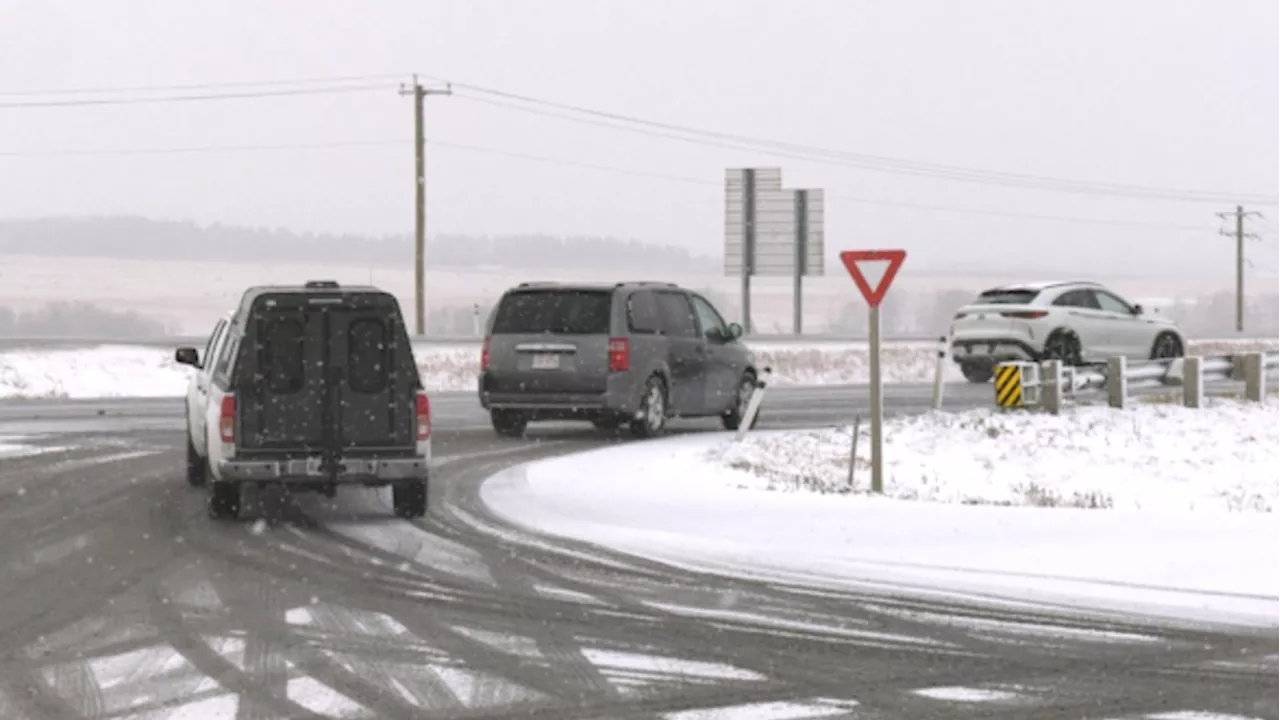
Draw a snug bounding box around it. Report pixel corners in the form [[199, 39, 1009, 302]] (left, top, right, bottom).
[[0, 217, 721, 273]]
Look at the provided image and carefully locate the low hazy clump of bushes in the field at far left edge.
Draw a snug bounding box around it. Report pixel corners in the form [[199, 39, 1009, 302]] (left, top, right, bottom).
[[0, 302, 170, 340]]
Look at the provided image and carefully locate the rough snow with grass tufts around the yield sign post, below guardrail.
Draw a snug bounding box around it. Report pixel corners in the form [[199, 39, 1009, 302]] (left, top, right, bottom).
[[708, 400, 1280, 512]]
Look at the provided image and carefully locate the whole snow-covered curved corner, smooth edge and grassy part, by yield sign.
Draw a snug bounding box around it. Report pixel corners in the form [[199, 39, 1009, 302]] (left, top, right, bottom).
[[481, 402, 1280, 626]]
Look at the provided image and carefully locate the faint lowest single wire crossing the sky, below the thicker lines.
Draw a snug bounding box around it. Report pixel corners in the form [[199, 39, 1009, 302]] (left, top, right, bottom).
[[0, 138, 1216, 233]]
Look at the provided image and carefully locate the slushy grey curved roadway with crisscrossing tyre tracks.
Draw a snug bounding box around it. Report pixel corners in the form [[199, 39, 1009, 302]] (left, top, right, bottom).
[[0, 386, 1280, 720]]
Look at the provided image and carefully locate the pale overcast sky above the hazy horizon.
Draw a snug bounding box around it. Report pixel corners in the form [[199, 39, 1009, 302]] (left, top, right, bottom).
[[0, 0, 1280, 275]]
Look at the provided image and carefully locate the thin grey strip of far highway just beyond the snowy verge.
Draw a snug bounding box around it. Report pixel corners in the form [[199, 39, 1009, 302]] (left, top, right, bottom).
[[0, 333, 1280, 351]]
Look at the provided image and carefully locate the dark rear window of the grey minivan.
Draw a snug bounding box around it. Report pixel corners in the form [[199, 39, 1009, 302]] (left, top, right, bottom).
[[492, 290, 613, 334]]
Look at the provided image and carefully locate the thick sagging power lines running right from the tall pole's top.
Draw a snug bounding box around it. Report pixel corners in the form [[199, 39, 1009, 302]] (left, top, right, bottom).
[[435, 82, 1280, 205]]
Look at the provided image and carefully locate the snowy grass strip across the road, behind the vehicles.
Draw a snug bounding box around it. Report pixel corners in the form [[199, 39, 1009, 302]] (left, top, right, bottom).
[[0, 341, 1280, 398]]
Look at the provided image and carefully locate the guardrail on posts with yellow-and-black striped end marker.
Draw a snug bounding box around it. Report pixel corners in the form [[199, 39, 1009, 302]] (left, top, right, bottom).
[[995, 352, 1280, 414]]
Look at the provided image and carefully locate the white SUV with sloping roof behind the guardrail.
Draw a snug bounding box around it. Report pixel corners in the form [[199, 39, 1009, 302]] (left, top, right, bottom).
[[950, 282, 1187, 383]]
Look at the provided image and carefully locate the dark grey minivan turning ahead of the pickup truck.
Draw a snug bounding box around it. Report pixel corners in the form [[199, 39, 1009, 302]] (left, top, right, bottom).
[[479, 282, 756, 438]]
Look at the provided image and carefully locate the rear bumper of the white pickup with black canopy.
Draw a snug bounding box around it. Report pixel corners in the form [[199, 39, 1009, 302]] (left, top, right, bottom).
[[218, 457, 430, 486]]
